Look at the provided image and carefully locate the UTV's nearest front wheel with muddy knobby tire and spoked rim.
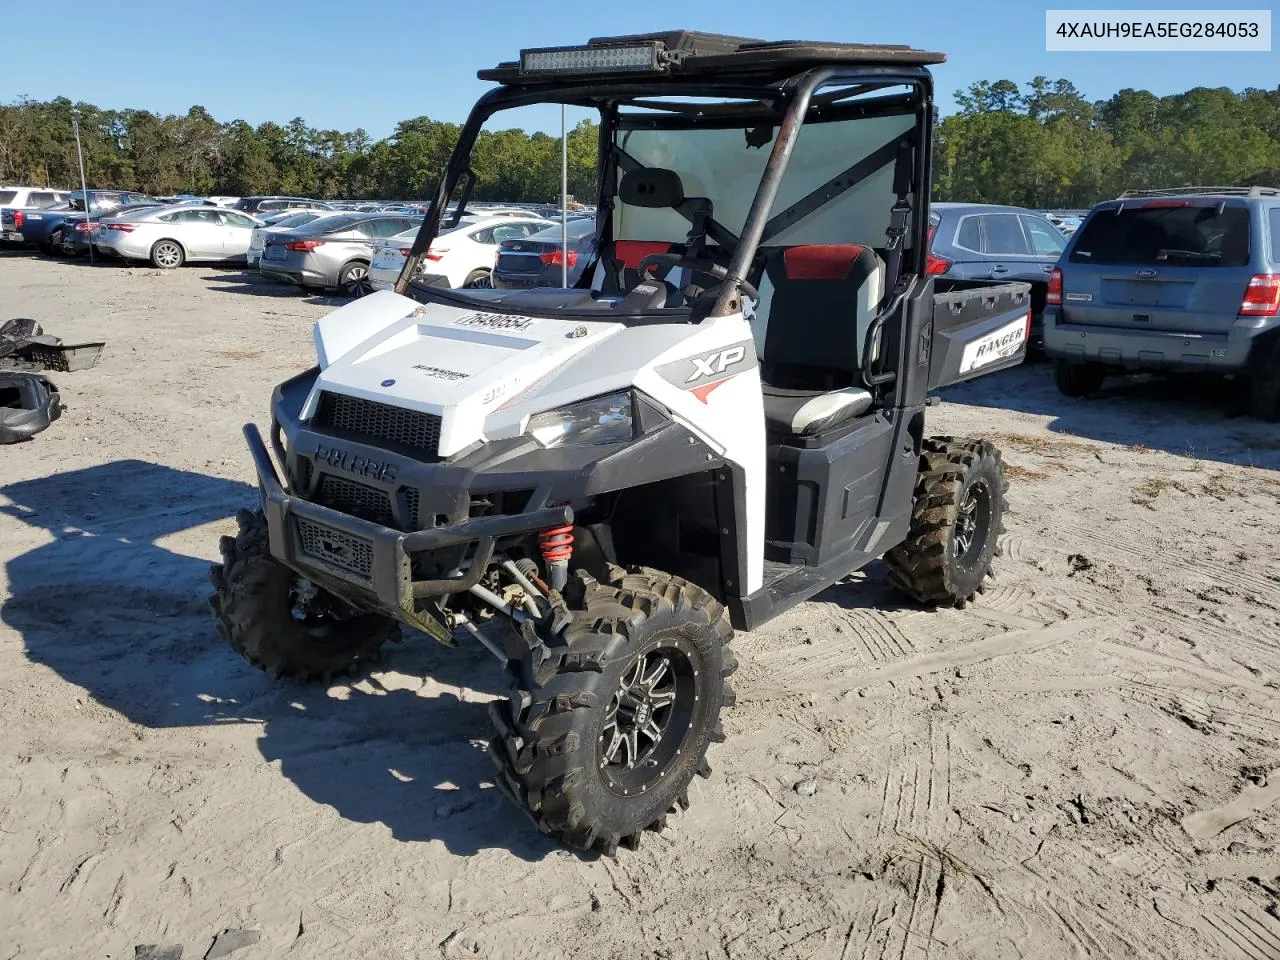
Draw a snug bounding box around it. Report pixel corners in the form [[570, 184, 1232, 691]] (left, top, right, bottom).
[[489, 568, 737, 855]]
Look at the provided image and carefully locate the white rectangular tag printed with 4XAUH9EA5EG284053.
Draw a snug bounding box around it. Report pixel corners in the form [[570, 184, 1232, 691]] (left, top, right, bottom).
[[1044, 10, 1271, 52]]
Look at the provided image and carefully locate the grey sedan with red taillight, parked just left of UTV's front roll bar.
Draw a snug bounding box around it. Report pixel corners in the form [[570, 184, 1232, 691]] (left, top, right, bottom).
[[259, 214, 421, 297]]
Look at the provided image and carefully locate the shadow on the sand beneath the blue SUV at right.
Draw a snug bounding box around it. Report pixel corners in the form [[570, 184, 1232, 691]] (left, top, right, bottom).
[[940, 364, 1280, 470]]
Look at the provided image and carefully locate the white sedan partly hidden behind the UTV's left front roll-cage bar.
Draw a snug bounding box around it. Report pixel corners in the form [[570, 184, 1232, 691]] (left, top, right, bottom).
[[369, 215, 553, 291]]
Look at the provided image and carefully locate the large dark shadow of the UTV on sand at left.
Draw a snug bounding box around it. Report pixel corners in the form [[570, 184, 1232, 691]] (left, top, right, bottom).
[[0, 461, 556, 860]]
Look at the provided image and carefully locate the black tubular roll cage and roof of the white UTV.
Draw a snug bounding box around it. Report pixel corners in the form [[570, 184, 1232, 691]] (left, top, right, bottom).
[[396, 31, 946, 316]]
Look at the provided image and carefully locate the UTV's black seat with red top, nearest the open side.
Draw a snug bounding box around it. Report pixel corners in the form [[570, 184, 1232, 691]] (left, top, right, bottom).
[[751, 243, 884, 436]]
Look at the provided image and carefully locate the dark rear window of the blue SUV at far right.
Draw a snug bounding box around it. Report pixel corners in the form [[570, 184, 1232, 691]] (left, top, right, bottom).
[[1071, 200, 1249, 266]]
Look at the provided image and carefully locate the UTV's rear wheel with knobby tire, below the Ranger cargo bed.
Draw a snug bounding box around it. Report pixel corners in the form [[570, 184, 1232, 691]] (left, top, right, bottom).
[[884, 436, 1009, 607]]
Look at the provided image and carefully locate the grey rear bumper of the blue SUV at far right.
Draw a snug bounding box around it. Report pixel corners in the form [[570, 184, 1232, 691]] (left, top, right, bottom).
[[1044, 306, 1280, 374]]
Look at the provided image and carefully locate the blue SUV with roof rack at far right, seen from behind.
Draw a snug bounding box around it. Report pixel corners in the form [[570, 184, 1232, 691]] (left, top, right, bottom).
[[1044, 187, 1280, 420]]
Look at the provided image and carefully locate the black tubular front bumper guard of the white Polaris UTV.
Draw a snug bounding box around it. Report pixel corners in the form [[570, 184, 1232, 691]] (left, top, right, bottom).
[[244, 424, 573, 619]]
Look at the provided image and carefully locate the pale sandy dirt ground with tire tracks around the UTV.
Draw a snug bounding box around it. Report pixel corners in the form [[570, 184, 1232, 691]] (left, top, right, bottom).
[[0, 255, 1280, 960]]
